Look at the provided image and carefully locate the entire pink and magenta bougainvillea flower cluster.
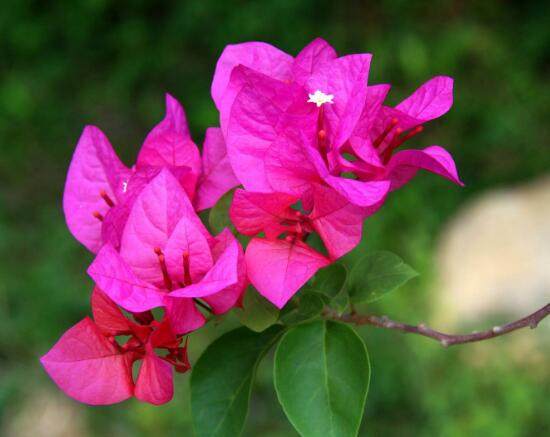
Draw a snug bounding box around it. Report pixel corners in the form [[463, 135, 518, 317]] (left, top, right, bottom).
[[42, 39, 461, 404]]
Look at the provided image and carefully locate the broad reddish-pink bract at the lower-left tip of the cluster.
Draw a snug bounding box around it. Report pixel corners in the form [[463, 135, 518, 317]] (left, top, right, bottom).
[[40, 317, 134, 405]]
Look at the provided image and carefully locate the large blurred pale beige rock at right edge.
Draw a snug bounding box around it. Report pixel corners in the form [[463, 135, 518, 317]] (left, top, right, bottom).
[[434, 177, 550, 329]]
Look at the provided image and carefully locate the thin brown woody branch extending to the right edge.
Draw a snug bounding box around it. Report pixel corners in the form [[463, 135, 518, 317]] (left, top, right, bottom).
[[324, 303, 550, 347]]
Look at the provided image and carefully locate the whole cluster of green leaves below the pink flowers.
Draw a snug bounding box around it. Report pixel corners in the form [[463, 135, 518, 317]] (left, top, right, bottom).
[[191, 232, 417, 437]]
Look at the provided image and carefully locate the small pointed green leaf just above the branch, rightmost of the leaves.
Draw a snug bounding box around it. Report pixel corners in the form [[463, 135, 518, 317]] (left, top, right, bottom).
[[350, 252, 418, 303]]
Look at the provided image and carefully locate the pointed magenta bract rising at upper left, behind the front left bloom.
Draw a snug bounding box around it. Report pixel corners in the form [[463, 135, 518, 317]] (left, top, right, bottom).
[[137, 94, 201, 195]]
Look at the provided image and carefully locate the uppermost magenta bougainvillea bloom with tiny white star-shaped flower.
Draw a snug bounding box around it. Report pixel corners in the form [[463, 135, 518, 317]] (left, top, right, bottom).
[[218, 40, 461, 207]]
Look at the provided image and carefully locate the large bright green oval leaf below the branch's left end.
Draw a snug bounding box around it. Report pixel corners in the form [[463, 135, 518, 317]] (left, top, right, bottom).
[[275, 321, 370, 437]]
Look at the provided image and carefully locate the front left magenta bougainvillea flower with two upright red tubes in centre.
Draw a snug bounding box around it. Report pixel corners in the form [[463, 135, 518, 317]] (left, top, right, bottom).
[[88, 169, 246, 334]]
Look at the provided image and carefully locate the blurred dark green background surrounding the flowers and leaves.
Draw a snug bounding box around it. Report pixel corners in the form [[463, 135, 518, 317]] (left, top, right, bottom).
[[0, 0, 550, 437]]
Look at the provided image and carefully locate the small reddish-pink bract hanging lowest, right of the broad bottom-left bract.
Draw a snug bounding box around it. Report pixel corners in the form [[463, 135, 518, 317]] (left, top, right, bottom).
[[134, 344, 174, 405]]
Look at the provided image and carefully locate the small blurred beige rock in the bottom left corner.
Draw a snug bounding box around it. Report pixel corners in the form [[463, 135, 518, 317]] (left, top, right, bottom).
[[0, 388, 89, 437]]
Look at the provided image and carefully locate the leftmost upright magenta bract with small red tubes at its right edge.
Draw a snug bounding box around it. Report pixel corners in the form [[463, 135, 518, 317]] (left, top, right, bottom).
[[63, 126, 130, 253]]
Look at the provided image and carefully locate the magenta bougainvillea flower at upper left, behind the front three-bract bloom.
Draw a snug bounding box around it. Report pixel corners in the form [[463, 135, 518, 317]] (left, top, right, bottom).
[[63, 94, 201, 253]]
